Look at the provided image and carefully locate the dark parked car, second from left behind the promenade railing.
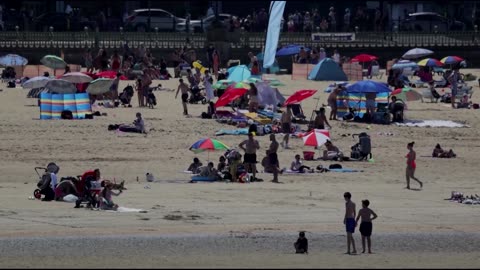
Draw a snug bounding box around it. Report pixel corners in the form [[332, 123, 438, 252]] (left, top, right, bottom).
[[33, 12, 95, 31]]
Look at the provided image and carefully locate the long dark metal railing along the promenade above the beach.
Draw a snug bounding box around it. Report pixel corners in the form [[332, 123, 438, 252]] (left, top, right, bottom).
[[0, 30, 480, 49]]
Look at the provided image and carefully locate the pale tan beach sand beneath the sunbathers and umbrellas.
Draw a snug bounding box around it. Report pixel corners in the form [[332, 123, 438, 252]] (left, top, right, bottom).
[[0, 70, 480, 268]]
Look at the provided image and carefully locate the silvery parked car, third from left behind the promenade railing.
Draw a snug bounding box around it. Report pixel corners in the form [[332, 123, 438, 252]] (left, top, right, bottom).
[[125, 8, 185, 32]]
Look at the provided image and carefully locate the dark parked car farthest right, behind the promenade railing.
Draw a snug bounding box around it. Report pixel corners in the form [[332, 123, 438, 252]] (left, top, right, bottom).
[[400, 12, 465, 32]]
